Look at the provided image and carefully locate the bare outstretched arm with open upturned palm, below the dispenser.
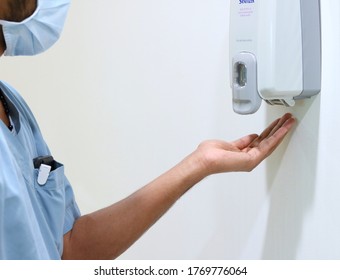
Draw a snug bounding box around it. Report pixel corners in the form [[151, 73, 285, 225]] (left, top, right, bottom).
[[63, 114, 295, 259]]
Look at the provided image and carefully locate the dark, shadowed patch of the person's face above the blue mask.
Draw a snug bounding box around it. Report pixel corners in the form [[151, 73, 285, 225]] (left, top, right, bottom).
[[5, 0, 37, 22]]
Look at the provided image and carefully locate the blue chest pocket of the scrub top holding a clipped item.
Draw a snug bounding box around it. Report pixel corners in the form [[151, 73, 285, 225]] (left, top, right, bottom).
[[34, 158, 66, 252]]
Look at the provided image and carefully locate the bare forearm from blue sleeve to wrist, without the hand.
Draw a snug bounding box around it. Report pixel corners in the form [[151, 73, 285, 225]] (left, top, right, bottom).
[[63, 152, 207, 259]]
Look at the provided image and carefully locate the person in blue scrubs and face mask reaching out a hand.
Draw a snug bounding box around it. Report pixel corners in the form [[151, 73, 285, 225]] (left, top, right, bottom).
[[0, 0, 295, 259]]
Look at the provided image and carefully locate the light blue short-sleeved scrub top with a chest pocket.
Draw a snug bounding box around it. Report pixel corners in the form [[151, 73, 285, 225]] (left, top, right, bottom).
[[0, 81, 80, 260]]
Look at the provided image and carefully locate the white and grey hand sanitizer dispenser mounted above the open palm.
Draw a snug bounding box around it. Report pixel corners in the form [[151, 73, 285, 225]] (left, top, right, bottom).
[[229, 0, 321, 114]]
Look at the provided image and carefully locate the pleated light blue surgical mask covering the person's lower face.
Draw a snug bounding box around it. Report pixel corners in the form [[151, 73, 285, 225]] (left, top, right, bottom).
[[0, 0, 70, 56]]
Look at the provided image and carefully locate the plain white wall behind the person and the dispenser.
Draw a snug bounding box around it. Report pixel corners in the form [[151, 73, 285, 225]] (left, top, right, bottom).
[[0, 0, 340, 259]]
